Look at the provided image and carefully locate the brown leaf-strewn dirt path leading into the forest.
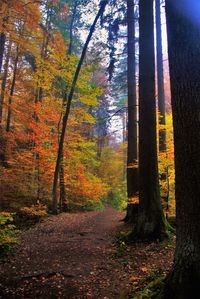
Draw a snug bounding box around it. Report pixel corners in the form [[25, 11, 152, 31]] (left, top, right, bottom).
[[0, 207, 130, 299]]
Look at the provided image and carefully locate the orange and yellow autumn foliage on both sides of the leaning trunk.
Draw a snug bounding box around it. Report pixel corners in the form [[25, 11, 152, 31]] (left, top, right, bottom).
[[0, 0, 107, 210]]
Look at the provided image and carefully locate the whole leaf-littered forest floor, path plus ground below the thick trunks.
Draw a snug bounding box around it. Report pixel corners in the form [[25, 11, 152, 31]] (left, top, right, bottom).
[[0, 207, 173, 299]]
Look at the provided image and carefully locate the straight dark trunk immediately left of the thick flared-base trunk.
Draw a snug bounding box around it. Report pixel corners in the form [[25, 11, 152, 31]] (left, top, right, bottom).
[[125, 0, 138, 221]]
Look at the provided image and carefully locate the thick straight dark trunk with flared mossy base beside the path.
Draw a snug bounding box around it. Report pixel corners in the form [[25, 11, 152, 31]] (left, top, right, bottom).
[[136, 0, 165, 240]]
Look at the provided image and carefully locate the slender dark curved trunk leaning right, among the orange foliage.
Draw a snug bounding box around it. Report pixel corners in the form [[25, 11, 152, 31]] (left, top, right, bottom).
[[52, 0, 108, 213]]
